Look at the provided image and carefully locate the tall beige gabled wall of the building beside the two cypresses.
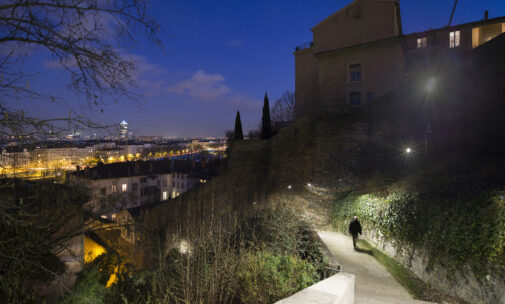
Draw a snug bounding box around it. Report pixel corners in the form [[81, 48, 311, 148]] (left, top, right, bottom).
[[294, 0, 404, 119]]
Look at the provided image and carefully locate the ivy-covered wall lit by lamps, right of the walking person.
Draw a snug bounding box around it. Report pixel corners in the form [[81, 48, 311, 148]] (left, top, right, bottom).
[[332, 160, 505, 303]]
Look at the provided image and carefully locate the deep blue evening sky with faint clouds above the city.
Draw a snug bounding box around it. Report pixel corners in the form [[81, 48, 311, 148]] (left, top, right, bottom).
[[13, 0, 505, 137]]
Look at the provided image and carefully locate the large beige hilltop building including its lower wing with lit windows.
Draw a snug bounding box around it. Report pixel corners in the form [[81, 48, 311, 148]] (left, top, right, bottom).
[[294, 0, 505, 119]]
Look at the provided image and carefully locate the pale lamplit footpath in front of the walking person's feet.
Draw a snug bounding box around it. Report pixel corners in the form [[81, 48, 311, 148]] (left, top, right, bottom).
[[318, 231, 428, 304]]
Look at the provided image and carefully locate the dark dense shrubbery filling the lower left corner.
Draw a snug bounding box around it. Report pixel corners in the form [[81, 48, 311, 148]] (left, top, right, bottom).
[[0, 179, 87, 303]]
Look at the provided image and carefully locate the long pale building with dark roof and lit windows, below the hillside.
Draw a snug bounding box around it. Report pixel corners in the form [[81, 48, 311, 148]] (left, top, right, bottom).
[[69, 160, 208, 220]]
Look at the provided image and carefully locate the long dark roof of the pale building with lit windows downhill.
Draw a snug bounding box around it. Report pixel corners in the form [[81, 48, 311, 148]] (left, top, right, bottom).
[[72, 159, 216, 180]]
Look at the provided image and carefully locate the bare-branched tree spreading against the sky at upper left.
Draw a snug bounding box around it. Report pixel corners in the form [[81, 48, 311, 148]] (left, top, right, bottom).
[[0, 0, 161, 136]]
